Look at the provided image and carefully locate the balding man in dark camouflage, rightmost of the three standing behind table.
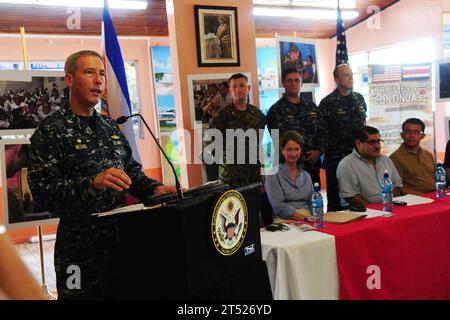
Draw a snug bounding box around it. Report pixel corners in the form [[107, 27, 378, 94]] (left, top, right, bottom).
[[319, 64, 367, 211]]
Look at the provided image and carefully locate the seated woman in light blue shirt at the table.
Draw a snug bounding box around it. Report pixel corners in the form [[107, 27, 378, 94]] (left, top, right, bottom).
[[264, 131, 314, 220]]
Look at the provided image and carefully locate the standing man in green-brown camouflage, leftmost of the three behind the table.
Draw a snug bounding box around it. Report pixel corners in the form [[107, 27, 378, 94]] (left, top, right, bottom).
[[211, 73, 266, 183]]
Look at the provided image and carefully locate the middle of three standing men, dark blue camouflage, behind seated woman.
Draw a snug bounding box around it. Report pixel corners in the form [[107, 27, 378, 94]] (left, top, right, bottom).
[[267, 68, 323, 184]]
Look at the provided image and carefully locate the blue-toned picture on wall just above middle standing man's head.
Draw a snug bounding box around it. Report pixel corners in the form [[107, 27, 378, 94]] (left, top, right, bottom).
[[276, 37, 319, 87]]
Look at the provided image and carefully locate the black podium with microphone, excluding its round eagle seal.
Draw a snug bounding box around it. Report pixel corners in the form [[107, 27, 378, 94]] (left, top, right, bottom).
[[114, 184, 272, 300]]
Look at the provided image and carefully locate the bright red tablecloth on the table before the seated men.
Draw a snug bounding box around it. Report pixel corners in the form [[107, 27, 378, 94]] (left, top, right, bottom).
[[320, 194, 450, 299]]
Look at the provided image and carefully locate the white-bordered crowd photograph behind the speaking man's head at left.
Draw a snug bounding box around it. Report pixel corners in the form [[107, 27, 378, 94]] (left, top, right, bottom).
[[0, 70, 67, 137]]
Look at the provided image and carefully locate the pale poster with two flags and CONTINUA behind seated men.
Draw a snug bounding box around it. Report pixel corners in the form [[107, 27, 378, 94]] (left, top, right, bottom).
[[367, 63, 434, 155]]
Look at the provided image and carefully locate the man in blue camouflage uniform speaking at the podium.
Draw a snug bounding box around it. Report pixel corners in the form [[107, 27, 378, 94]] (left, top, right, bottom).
[[28, 51, 176, 299]]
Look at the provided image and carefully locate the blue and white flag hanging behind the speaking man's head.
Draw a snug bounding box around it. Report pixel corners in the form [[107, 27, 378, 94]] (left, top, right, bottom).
[[102, 0, 141, 163]]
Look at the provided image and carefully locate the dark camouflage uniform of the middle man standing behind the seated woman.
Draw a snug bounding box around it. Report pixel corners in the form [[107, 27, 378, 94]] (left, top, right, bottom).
[[266, 96, 324, 184]]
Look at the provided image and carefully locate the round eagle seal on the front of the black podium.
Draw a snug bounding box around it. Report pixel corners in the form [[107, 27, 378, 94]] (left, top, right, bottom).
[[211, 190, 248, 256]]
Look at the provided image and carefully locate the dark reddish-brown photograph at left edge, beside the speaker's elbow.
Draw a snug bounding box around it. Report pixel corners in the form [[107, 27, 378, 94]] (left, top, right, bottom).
[[0, 139, 56, 227]]
